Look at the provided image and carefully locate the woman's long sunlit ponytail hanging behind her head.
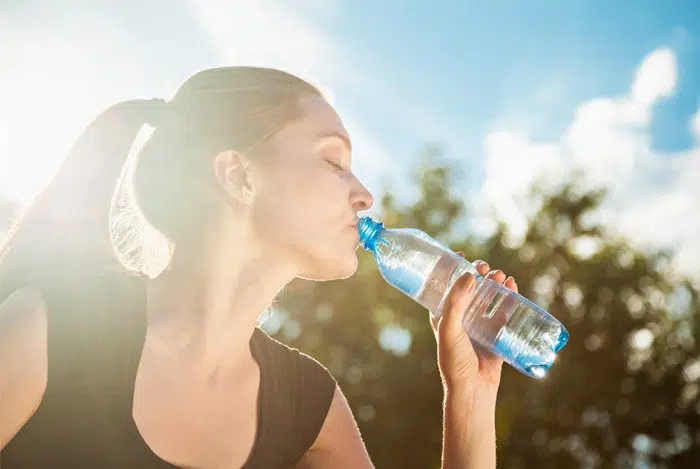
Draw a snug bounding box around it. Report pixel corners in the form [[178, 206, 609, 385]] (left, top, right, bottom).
[[0, 99, 165, 302]]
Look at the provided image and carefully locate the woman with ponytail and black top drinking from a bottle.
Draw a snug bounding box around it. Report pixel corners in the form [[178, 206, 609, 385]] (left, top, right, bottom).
[[0, 67, 517, 469]]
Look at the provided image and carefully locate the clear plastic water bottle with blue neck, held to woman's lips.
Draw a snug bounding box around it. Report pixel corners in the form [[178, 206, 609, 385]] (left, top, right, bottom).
[[358, 217, 569, 378]]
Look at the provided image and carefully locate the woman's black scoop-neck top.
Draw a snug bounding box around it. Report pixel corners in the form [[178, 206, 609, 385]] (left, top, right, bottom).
[[0, 274, 336, 469]]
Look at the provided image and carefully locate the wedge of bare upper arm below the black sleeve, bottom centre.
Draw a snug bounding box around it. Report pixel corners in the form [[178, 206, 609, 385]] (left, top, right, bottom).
[[295, 386, 374, 469]]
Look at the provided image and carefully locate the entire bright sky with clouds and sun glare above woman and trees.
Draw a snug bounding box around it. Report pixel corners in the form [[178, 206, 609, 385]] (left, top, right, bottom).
[[0, 0, 700, 275]]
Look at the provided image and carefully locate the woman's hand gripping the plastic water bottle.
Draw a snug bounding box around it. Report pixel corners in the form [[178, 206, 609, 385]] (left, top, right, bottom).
[[430, 252, 518, 390]]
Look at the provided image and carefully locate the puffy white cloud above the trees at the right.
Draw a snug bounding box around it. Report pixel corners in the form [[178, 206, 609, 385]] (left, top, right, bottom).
[[480, 49, 700, 274]]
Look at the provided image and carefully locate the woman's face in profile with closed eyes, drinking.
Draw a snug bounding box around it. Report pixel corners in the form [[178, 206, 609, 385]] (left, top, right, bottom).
[[252, 94, 373, 280]]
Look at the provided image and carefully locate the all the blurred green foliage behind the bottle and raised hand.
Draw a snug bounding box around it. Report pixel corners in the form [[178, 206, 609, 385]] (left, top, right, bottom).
[[272, 148, 700, 469]]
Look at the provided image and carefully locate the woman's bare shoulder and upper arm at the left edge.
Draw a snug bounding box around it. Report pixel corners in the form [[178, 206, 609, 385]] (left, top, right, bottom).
[[0, 287, 47, 449]]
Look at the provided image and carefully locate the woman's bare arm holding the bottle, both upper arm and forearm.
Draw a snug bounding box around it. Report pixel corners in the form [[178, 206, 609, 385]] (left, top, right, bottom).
[[295, 262, 518, 469]]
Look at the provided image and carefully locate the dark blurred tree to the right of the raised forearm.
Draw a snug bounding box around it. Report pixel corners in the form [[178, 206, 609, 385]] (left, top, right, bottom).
[[492, 184, 700, 468]]
